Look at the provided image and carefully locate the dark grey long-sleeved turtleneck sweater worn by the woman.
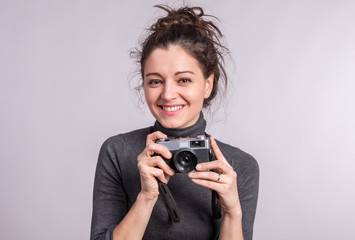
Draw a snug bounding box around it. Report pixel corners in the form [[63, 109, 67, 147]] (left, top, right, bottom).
[[90, 114, 259, 240]]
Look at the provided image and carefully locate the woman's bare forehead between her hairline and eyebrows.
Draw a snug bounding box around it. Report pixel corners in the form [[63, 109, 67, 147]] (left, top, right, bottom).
[[144, 46, 202, 73]]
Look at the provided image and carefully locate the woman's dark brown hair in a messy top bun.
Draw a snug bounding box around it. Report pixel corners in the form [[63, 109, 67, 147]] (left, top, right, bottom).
[[136, 5, 228, 107]]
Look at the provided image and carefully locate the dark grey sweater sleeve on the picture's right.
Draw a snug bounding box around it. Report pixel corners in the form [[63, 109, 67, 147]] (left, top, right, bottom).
[[237, 155, 259, 240]]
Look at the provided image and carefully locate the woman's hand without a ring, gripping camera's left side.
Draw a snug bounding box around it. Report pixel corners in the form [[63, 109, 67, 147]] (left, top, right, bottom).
[[137, 131, 174, 200]]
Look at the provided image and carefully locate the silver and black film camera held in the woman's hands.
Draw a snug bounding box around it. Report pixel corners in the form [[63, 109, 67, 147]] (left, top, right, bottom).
[[156, 135, 213, 173]]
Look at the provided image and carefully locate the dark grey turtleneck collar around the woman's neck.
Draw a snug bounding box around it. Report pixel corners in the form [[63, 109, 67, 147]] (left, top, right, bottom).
[[154, 112, 207, 137]]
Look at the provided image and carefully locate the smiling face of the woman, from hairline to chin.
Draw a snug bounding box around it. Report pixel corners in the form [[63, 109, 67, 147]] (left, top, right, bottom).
[[143, 46, 214, 128]]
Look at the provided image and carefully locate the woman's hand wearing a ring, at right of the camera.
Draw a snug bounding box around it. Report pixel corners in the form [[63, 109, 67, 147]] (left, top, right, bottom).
[[189, 137, 242, 215]]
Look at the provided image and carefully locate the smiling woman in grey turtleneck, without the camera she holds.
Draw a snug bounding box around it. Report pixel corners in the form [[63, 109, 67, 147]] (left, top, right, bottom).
[[91, 6, 259, 240]]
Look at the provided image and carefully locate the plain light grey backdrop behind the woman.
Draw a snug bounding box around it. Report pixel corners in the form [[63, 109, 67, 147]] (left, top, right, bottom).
[[0, 0, 355, 240]]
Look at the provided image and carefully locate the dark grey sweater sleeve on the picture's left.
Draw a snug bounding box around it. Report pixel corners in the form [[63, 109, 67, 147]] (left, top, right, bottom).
[[90, 135, 127, 240]]
